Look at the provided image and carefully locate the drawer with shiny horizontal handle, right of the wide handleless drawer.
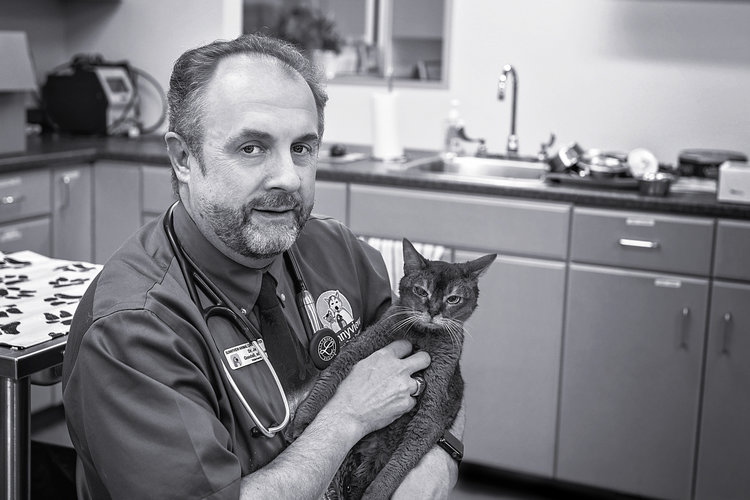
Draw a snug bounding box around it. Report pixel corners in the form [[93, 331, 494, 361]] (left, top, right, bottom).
[[570, 208, 714, 276]]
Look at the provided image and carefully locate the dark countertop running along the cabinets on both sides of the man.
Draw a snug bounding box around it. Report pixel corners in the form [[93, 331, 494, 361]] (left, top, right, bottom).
[[0, 135, 750, 219]]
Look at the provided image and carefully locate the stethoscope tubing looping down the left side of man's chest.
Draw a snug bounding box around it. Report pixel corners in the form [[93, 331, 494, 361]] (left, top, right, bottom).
[[164, 201, 290, 438]]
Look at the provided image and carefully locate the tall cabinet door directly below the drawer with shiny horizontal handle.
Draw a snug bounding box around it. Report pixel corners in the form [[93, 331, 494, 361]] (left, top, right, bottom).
[[557, 264, 708, 499]]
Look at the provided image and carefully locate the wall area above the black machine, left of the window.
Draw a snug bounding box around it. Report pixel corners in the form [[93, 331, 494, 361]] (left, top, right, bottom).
[[0, 0, 242, 133]]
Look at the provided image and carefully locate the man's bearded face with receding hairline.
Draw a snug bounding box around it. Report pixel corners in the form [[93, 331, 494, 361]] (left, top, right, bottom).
[[183, 55, 320, 259]]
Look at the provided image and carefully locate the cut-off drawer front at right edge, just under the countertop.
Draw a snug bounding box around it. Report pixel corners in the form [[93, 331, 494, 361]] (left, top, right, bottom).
[[714, 220, 750, 281]]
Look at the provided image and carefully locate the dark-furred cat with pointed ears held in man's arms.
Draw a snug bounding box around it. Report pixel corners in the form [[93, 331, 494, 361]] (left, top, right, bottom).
[[292, 239, 496, 499]]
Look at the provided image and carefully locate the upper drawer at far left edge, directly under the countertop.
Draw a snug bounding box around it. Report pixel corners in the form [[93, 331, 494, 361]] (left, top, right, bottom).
[[0, 169, 51, 222]]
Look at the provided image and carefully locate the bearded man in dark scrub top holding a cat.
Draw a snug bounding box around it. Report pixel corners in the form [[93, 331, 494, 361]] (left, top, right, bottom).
[[63, 36, 463, 500]]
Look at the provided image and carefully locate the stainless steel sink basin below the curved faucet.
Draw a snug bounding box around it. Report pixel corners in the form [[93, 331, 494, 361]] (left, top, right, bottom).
[[404, 156, 549, 181]]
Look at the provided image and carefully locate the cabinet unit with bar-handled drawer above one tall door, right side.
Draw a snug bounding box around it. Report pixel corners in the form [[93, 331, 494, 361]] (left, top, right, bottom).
[[557, 208, 713, 499]]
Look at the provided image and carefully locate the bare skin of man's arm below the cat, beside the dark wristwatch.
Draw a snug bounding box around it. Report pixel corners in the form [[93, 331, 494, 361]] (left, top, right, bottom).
[[391, 446, 458, 500]]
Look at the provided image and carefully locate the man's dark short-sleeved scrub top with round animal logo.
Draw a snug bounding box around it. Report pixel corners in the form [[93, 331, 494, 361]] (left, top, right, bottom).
[[63, 205, 391, 500]]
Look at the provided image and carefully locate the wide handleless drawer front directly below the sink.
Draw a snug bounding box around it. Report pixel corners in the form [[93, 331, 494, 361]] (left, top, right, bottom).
[[349, 185, 570, 259]]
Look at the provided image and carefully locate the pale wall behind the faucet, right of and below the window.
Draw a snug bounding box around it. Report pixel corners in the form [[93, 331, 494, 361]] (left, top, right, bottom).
[[326, 0, 750, 166]]
